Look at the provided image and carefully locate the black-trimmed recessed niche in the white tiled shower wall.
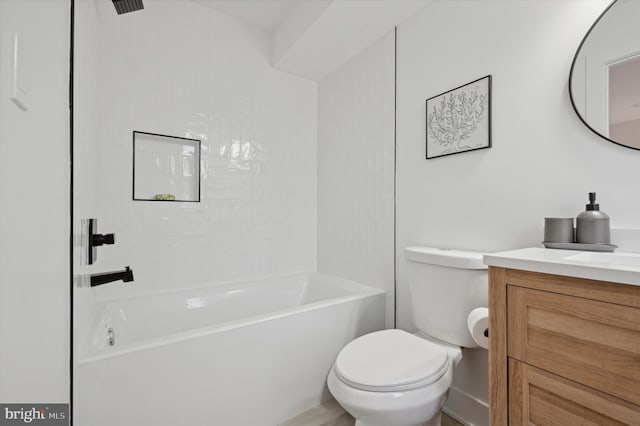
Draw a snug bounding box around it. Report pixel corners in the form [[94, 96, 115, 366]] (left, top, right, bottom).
[[133, 131, 201, 202]]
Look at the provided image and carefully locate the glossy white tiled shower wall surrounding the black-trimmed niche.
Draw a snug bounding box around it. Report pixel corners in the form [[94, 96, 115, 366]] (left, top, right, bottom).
[[76, 0, 317, 316]]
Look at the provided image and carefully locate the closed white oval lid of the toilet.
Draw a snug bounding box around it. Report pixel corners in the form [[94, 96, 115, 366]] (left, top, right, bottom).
[[335, 330, 448, 392]]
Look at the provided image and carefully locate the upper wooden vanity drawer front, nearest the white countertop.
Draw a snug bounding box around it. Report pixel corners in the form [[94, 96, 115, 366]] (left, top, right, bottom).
[[507, 285, 640, 404]]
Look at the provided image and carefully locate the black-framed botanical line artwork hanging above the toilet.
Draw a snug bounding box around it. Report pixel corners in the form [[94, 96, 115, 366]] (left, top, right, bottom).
[[427, 75, 491, 160]]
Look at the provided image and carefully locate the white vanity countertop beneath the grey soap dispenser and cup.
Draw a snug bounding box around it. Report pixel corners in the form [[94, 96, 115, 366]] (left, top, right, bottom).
[[484, 247, 640, 286]]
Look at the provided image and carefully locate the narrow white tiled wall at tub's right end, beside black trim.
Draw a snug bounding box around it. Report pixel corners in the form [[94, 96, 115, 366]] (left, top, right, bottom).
[[318, 31, 395, 327]]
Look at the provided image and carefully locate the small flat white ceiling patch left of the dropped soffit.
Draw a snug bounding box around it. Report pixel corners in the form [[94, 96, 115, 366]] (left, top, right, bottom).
[[195, 0, 300, 33]]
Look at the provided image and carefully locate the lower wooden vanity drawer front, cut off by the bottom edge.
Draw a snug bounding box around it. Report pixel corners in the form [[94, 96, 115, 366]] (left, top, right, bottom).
[[509, 359, 640, 426]]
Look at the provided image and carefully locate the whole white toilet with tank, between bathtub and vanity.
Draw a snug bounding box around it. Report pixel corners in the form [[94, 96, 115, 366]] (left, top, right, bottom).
[[327, 247, 488, 426]]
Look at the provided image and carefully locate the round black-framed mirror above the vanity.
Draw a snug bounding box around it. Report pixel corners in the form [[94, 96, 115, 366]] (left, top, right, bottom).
[[569, 0, 640, 150]]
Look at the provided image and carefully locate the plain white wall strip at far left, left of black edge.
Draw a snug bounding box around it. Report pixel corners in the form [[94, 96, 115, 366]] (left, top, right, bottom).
[[0, 0, 70, 403]]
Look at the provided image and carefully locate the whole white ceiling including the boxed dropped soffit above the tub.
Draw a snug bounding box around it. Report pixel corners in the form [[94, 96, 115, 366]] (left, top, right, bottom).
[[190, 0, 432, 81]]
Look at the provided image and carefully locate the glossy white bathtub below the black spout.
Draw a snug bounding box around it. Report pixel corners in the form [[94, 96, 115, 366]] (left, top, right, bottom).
[[73, 274, 384, 426]]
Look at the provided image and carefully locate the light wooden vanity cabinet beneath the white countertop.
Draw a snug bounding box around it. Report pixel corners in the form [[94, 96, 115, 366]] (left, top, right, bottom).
[[489, 266, 640, 426]]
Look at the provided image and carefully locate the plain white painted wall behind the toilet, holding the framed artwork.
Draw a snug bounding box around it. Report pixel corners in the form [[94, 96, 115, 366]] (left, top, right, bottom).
[[396, 0, 640, 424]]
